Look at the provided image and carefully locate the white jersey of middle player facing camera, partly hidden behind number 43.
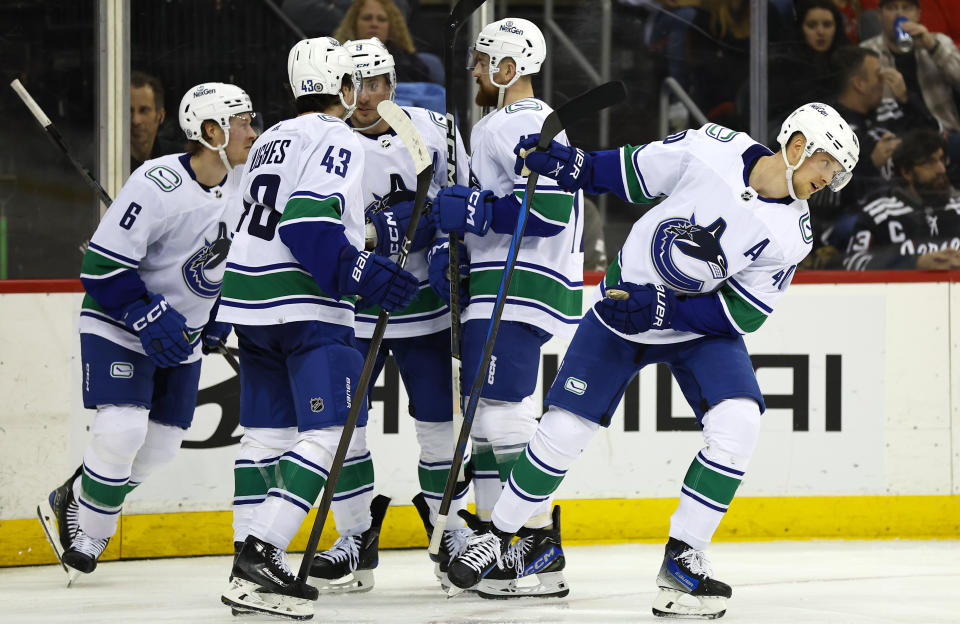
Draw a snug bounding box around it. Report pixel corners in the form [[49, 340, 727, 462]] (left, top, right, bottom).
[[356, 106, 470, 338]]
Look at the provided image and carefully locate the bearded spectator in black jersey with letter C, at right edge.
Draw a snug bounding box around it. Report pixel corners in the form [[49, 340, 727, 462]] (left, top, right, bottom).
[[844, 129, 960, 271]]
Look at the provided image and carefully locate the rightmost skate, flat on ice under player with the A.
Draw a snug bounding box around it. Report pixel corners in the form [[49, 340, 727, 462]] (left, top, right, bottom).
[[653, 537, 733, 620]]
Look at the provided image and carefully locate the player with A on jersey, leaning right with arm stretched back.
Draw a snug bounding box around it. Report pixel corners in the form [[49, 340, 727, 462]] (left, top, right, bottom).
[[449, 103, 859, 618]]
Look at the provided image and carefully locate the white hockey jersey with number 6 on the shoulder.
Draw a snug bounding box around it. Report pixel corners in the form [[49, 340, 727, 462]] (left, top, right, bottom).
[[80, 154, 241, 362]]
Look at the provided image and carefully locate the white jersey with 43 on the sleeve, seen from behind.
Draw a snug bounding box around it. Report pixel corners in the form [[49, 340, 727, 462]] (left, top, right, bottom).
[[217, 114, 364, 327]]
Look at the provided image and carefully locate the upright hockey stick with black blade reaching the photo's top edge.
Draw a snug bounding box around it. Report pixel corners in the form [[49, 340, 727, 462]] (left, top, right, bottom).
[[444, 0, 484, 490]]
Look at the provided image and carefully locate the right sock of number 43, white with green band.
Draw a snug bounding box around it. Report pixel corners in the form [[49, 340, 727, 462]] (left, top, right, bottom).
[[249, 427, 343, 550]]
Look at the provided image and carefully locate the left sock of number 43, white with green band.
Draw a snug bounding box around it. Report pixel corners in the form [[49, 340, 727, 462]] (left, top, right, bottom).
[[233, 427, 297, 542]]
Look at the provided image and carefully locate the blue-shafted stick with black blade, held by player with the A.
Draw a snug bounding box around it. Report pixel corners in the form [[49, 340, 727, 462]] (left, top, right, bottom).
[[430, 81, 627, 553]]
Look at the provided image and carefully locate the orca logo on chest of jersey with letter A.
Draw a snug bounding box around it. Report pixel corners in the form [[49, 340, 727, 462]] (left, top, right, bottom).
[[650, 215, 727, 292]]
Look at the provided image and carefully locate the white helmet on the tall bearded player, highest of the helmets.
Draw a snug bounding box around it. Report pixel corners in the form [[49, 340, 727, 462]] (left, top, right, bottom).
[[473, 17, 547, 88]]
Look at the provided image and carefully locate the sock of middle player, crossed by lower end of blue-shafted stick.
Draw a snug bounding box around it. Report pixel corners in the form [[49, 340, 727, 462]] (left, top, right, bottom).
[[414, 420, 466, 529]]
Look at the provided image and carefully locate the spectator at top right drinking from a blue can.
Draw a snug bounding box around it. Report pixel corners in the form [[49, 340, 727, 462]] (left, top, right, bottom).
[[860, 0, 960, 178]]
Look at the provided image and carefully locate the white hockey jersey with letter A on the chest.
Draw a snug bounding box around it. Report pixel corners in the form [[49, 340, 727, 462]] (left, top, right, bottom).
[[596, 124, 812, 343]]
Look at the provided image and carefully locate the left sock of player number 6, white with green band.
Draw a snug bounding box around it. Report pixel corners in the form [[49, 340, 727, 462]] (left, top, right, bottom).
[[77, 405, 150, 539]]
